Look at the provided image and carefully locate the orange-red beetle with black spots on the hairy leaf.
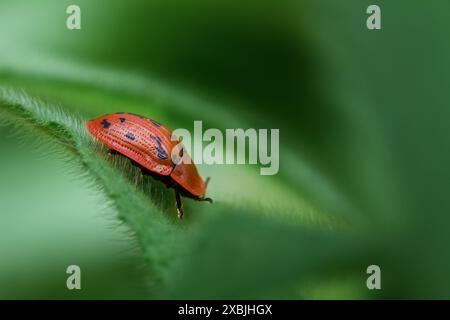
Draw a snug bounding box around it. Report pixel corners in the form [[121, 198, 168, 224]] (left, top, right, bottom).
[[87, 112, 212, 219]]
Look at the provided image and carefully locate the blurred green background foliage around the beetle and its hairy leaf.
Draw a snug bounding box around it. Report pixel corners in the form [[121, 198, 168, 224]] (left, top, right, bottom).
[[0, 0, 450, 299]]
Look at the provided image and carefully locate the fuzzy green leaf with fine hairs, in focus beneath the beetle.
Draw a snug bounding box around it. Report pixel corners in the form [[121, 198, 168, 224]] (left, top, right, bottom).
[[0, 83, 352, 295]]
